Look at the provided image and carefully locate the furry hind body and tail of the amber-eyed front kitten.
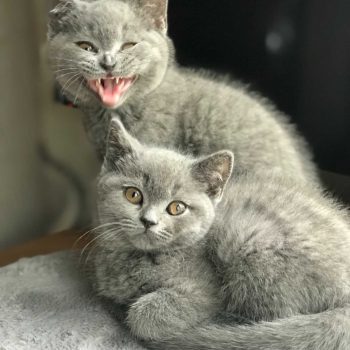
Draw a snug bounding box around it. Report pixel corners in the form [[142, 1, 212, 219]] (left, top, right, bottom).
[[149, 176, 350, 350]]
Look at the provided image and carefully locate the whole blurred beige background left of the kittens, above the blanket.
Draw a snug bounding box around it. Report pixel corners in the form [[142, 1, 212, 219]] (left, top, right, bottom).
[[0, 0, 98, 249]]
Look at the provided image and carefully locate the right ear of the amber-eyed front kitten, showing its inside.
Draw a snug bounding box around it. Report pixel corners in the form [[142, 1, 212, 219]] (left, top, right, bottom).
[[192, 151, 234, 202]]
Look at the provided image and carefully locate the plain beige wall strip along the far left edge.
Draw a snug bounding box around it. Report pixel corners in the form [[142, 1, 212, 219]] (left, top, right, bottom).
[[0, 0, 47, 249]]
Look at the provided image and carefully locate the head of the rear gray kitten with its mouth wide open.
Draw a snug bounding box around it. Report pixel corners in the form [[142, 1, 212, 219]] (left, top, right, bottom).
[[48, 0, 169, 109]]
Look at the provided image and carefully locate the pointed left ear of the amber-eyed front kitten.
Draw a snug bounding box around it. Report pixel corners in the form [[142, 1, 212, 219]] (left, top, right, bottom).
[[104, 118, 141, 170]]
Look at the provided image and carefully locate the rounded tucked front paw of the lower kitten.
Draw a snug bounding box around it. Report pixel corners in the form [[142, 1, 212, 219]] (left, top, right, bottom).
[[127, 289, 188, 340]]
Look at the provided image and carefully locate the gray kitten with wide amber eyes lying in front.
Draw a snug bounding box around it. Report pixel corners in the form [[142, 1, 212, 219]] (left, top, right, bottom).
[[91, 120, 350, 350]]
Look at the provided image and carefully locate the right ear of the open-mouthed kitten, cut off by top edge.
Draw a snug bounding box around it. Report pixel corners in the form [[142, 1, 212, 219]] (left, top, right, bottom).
[[139, 0, 168, 34]]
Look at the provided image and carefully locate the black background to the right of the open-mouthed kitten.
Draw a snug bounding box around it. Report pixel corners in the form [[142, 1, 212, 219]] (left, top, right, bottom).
[[169, 0, 350, 175]]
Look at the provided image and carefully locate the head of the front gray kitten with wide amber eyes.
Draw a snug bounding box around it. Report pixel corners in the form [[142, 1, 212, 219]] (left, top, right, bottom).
[[98, 120, 233, 251]]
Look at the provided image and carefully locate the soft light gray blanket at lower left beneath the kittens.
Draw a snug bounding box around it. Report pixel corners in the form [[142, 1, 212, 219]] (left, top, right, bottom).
[[0, 252, 144, 350]]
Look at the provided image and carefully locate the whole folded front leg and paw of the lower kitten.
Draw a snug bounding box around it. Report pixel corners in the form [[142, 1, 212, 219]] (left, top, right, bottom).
[[127, 282, 218, 340]]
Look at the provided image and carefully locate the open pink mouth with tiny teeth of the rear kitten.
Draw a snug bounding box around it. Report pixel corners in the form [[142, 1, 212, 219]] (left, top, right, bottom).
[[88, 77, 136, 108]]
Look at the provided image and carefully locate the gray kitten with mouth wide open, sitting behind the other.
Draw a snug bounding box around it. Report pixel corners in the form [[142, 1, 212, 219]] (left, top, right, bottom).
[[49, 0, 317, 182]]
